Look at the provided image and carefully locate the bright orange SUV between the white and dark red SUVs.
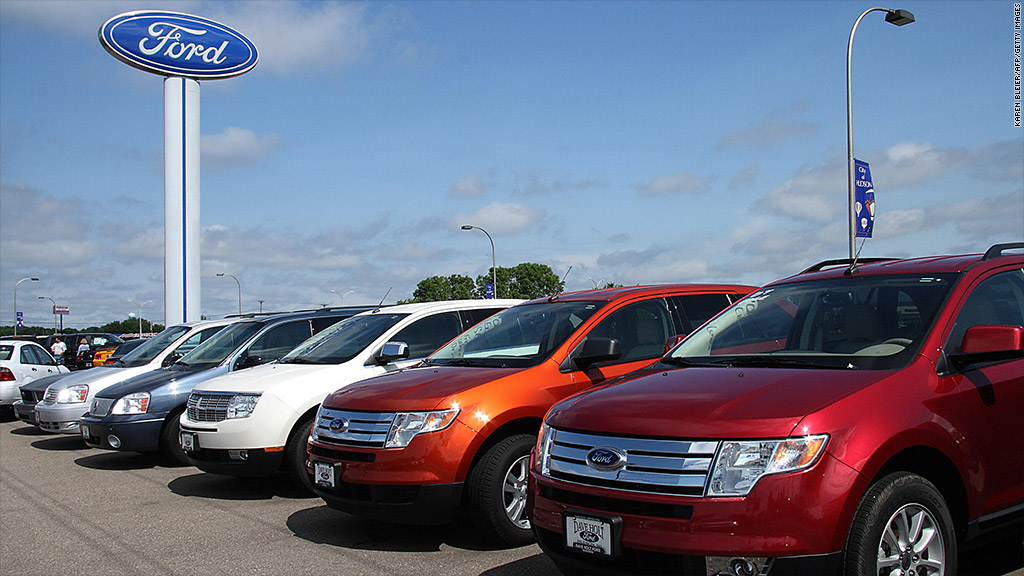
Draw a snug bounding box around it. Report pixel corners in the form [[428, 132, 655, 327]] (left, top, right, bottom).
[[309, 285, 753, 544]]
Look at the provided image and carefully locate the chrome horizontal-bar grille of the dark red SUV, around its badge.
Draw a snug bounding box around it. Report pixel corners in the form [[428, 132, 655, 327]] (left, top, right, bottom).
[[545, 429, 719, 496]]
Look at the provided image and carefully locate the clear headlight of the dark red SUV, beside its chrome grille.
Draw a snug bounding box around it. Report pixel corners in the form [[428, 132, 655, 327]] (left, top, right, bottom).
[[708, 435, 828, 496]]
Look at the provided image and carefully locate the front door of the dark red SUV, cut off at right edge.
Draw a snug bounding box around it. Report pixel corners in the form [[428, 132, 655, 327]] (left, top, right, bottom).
[[943, 269, 1024, 516]]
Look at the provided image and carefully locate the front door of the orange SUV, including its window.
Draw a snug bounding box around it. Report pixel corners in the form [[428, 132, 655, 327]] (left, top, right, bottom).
[[570, 297, 677, 390]]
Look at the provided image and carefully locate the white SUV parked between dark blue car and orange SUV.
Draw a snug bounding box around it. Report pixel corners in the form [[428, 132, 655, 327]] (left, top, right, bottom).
[[179, 299, 522, 488]]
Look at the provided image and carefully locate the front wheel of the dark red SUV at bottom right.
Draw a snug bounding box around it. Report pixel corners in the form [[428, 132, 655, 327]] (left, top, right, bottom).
[[844, 472, 956, 576]]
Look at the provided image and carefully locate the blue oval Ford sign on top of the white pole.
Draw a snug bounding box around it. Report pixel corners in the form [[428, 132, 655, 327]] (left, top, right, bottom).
[[99, 10, 259, 80]]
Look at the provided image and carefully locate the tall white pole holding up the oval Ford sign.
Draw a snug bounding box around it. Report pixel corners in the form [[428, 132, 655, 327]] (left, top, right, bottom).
[[164, 77, 202, 325]]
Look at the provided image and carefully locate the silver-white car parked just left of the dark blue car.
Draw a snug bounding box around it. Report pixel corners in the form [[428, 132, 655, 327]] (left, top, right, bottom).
[[36, 320, 236, 434]]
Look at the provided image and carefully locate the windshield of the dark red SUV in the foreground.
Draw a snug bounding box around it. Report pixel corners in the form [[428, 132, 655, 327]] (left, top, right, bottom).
[[663, 275, 956, 370]]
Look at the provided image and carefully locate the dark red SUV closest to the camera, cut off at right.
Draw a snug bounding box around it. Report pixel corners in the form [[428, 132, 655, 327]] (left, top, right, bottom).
[[527, 243, 1024, 576]]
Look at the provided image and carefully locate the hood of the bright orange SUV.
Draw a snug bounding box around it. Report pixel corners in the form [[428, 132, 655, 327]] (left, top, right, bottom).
[[324, 366, 522, 412]]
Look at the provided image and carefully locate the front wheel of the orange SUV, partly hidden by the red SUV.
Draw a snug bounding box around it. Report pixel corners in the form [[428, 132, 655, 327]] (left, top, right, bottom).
[[466, 434, 537, 546]]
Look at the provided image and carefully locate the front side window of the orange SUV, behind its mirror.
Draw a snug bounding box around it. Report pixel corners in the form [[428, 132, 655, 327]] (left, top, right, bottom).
[[588, 298, 675, 362]]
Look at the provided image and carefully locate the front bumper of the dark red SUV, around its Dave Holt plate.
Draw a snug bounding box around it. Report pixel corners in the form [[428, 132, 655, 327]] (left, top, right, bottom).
[[527, 454, 866, 576]]
